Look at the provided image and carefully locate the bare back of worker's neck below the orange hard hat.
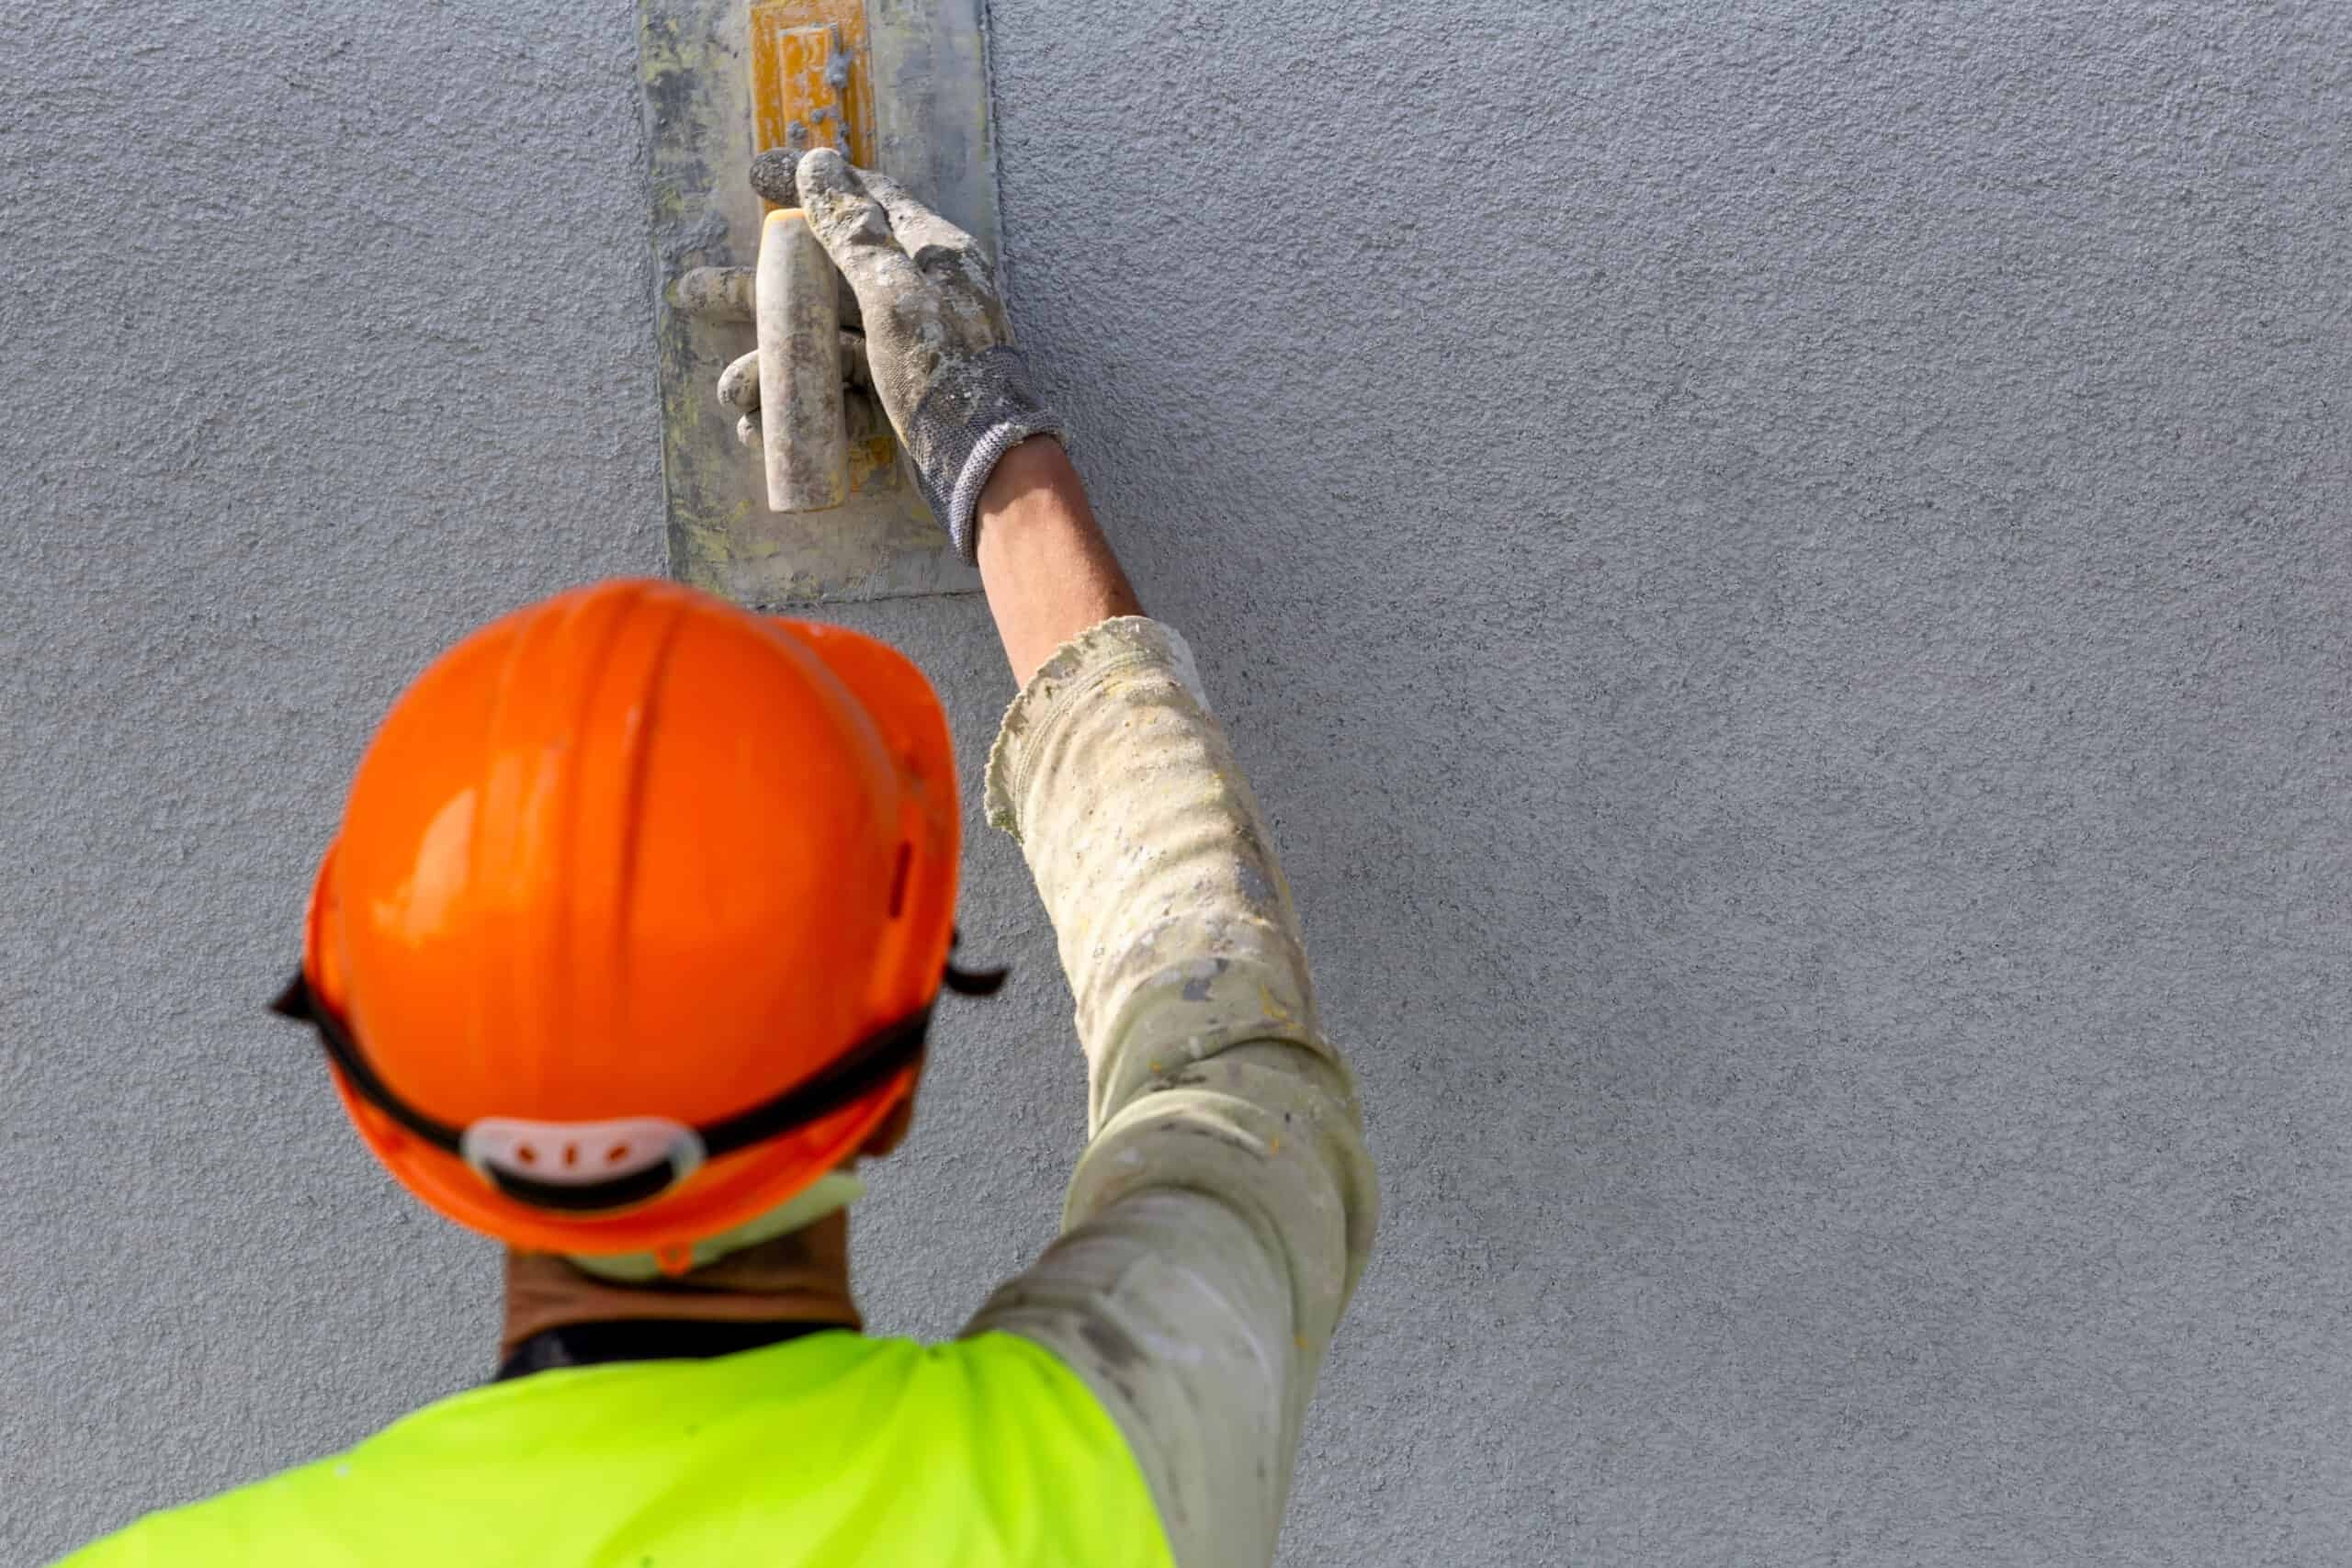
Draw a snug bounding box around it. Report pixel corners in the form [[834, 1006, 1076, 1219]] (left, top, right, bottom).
[[499, 1213, 861, 1359]]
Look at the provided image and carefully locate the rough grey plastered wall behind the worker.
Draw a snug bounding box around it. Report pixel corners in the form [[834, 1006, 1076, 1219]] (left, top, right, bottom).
[[0, 0, 2352, 1568]]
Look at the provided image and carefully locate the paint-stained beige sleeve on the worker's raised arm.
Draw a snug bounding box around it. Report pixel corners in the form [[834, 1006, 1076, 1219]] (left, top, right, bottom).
[[974, 618, 1376, 1568]]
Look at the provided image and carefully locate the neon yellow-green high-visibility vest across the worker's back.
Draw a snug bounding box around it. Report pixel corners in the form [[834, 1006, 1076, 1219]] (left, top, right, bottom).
[[66, 1333, 1171, 1568]]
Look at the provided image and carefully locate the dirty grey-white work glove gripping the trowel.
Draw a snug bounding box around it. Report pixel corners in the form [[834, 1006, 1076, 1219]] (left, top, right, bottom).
[[719, 148, 1066, 562]]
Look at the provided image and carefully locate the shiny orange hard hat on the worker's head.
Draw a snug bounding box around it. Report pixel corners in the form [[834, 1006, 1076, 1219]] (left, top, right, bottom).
[[280, 581, 959, 1267]]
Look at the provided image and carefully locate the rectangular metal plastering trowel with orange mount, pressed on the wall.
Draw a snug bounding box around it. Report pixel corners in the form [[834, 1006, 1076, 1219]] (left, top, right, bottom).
[[639, 0, 997, 604]]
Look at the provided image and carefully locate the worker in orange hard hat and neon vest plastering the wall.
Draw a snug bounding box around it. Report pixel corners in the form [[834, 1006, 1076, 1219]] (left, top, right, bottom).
[[55, 151, 1374, 1568]]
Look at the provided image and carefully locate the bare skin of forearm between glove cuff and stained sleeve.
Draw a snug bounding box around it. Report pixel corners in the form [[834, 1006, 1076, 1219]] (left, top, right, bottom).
[[978, 434, 1143, 684]]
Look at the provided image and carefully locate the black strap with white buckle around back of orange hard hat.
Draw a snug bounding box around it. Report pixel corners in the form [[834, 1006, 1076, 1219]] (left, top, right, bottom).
[[270, 976, 932, 1213]]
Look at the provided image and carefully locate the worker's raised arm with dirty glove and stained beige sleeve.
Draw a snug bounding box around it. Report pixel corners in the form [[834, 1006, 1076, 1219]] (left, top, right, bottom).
[[799, 152, 1376, 1568]]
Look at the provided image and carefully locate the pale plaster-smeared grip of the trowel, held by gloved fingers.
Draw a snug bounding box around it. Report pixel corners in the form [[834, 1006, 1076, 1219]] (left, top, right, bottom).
[[752, 207, 849, 513]]
